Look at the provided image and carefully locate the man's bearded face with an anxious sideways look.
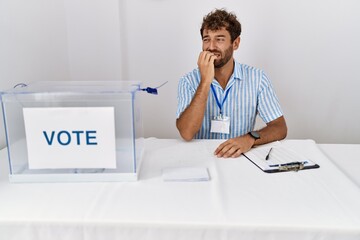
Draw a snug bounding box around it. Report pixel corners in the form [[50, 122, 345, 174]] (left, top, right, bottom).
[[202, 28, 234, 68]]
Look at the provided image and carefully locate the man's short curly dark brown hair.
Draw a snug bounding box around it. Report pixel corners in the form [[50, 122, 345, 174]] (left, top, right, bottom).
[[200, 9, 241, 42]]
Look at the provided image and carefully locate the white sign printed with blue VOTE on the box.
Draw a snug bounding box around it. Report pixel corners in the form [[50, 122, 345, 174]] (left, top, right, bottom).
[[23, 107, 116, 169]]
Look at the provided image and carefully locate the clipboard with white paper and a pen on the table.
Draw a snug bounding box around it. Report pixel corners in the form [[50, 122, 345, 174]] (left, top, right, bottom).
[[242, 142, 320, 173]]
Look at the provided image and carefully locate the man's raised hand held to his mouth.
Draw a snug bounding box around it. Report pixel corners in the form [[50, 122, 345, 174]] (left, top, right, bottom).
[[198, 51, 216, 84]]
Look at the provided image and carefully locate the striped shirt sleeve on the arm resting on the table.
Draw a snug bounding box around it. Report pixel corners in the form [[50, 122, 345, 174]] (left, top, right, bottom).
[[258, 73, 283, 123]]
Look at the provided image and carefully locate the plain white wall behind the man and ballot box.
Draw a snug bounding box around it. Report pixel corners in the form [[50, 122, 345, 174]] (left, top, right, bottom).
[[0, 0, 360, 144]]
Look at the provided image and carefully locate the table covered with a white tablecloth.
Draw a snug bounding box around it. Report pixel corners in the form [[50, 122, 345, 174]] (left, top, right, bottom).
[[0, 139, 360, 240]]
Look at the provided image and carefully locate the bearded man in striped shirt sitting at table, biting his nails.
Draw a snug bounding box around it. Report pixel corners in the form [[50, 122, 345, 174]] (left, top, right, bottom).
[[176, 9, 287, 158]]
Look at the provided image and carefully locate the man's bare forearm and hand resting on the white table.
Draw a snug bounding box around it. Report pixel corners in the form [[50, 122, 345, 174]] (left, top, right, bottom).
[[214, 116, 287, 158]]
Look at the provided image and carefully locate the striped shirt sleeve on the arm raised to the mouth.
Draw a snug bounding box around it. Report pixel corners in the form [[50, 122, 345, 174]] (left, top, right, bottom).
[[176, 77, 195, 118]]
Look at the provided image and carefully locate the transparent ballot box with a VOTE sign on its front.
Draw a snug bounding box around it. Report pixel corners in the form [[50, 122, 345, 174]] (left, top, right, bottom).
[[1, 81, 143, 182]]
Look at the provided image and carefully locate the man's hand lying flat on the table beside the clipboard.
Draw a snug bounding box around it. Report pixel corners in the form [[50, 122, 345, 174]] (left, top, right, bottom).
[[214, 134, 255, 158]]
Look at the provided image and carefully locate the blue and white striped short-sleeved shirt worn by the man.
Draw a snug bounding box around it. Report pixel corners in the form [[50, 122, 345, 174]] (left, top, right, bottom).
[[176, 61, 283, 139]]
